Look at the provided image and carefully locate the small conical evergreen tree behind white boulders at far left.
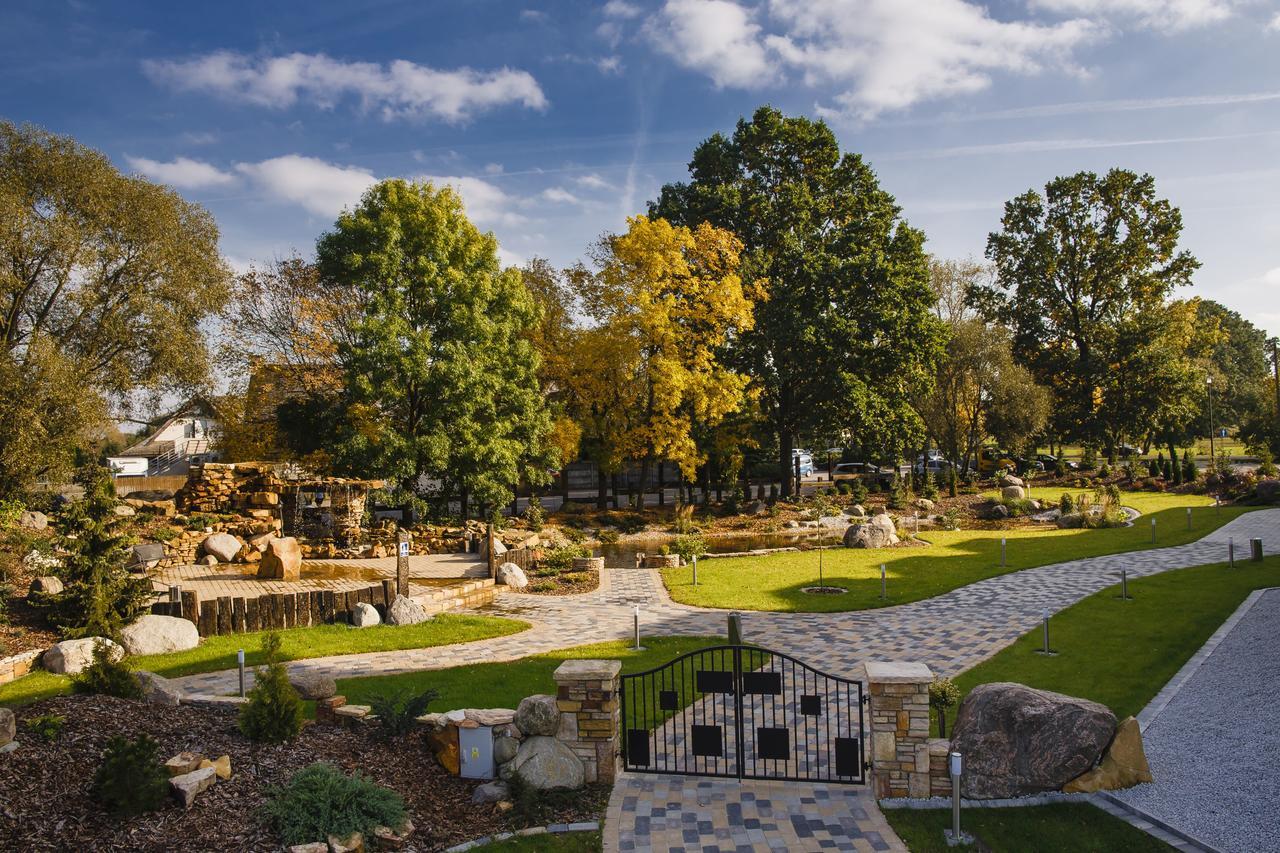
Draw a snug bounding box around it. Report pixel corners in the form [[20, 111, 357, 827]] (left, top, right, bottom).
[[50, 465, 152, 637]]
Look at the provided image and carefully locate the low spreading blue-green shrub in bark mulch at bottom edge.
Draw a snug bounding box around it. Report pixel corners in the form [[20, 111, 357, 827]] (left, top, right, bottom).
[[261, 762, 408, 845]]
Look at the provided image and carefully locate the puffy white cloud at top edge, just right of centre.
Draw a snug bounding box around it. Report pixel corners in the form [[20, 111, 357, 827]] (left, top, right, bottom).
[[646, 0, 778, 87]]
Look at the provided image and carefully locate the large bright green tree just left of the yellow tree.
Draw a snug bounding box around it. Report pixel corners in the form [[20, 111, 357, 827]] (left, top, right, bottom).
[[316, 181, 557, 514]]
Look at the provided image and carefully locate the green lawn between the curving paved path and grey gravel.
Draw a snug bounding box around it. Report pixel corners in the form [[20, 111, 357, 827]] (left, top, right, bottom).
[[952, 557, 1280, 717]]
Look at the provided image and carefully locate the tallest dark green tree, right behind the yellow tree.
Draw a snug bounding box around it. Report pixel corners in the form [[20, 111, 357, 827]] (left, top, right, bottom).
[[649, 106, 942, 494]]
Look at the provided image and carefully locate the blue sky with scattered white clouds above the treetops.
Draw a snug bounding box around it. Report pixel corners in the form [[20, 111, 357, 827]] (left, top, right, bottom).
[[0, 0, 1280, 334]]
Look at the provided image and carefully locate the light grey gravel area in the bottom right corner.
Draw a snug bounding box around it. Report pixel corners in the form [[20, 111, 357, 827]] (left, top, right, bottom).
[[1116, 590, 1280, 853]]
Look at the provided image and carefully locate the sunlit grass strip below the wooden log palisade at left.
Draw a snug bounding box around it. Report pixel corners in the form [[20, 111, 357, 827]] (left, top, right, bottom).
[[0, 613, 529, 706]]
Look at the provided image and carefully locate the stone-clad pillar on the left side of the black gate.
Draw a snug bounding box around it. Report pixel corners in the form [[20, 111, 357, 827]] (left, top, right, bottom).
[[553, 660, 622, 785]]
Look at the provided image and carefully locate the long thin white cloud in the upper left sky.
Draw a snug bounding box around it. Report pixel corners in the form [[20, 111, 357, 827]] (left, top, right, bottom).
[[143, 50, 547, 122]]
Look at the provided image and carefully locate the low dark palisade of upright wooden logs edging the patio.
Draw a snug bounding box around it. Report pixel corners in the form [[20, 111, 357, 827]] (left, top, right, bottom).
[[151, 580, 396, 637]]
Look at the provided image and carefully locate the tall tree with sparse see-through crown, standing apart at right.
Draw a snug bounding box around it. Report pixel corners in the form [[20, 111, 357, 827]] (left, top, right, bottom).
[[973, 169, 1199, 451]]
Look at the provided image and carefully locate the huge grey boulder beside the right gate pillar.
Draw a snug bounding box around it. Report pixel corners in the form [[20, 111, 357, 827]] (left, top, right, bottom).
[[951, 681, 1116, 799]]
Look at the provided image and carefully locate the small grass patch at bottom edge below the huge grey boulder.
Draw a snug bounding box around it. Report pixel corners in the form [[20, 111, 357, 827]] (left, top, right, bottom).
[[884, 803, 1172, 853]]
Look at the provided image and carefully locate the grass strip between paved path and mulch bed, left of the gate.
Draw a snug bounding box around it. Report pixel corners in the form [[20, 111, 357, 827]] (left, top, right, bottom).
[[338, 637, 724, 710]]
